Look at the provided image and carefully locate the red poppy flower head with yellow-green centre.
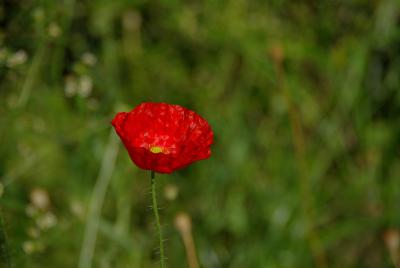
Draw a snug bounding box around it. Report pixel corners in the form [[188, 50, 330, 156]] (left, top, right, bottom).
[[112, 102, 213, 173]]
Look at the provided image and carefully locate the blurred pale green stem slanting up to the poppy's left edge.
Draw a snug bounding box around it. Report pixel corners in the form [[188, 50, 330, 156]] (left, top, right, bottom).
[[78, 129, 118, 268]]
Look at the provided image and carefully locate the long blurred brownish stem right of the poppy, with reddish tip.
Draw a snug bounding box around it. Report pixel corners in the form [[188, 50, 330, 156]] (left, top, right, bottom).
[[272, 45, 328, 268]]
